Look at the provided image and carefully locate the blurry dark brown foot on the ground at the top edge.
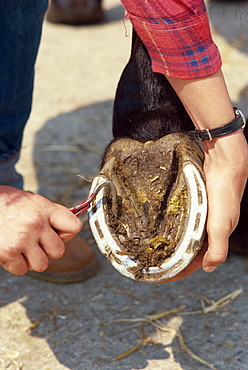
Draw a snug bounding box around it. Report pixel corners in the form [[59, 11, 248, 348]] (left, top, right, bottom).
[[46, 0, 104, 25]]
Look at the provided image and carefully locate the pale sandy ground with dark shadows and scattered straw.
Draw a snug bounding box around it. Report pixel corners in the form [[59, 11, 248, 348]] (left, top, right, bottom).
[[0, 0, 248, 370]]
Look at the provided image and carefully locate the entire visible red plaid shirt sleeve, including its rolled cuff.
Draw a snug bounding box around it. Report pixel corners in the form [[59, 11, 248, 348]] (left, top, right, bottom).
[[122, 0, 221, 78]]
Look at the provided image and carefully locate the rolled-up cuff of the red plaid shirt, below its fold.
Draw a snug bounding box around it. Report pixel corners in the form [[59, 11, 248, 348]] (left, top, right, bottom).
[[127, 12, 221, 78]]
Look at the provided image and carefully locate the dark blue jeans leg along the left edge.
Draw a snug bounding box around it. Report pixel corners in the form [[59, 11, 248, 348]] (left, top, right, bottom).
[[0, 0, 48, 188]]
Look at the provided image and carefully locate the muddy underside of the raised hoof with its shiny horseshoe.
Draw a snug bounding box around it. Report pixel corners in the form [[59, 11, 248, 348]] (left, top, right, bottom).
[[89, 133, 207, 282]]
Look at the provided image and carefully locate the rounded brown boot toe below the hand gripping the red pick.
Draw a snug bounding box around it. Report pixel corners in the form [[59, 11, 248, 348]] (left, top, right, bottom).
[[27, 235, 99, 283]]
